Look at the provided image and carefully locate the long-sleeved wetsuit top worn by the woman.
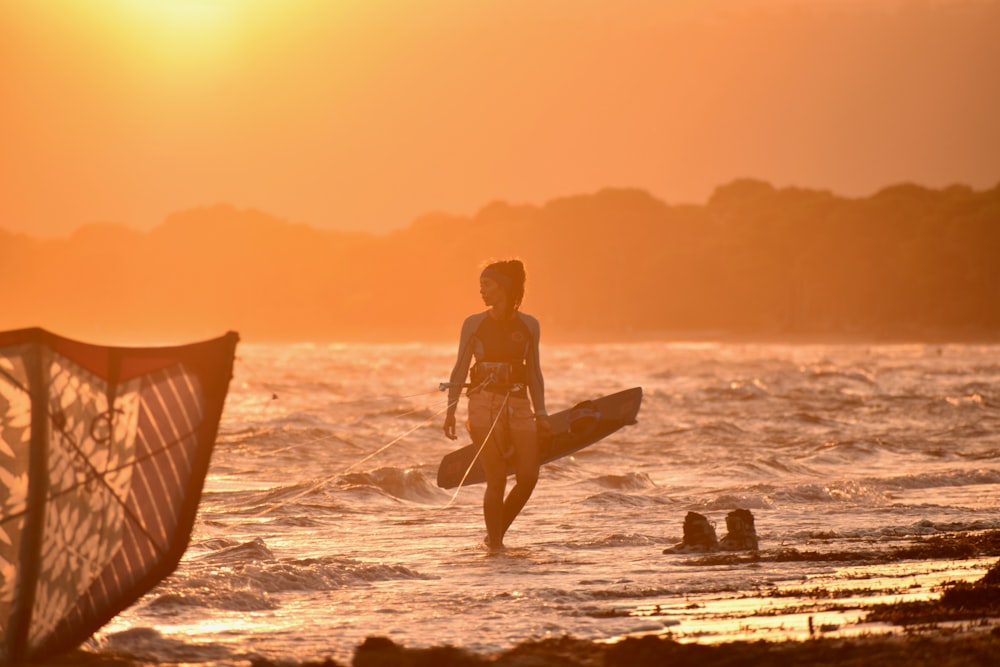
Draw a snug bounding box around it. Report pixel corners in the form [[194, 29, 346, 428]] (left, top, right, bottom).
[[448, 310, 546, 415]]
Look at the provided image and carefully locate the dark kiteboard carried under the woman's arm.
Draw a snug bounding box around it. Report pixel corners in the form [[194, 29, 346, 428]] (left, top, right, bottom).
[[437, 387, 642, 489]]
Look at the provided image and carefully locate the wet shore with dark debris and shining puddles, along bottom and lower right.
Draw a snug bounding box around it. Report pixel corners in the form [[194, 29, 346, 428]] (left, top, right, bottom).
[[58, 529, 1000, 667]]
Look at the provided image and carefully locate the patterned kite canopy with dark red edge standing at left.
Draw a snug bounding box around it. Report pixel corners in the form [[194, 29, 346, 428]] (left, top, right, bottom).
[[0, 329, 239, 663]]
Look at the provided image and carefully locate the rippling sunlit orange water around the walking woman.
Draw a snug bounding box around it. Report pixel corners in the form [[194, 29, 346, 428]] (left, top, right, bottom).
[[89, 343, 1000, 664]]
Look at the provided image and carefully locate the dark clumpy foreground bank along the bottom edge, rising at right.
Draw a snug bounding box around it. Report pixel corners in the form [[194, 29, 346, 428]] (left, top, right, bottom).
[[344, 552, 1000, 667]]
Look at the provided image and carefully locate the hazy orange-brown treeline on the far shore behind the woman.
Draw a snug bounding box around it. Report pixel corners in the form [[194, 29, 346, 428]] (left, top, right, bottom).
[[0, 180, 1000, 341]]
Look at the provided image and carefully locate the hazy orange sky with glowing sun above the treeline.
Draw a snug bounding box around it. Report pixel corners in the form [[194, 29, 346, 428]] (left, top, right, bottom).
[[0, 0, 1000, 236]]
